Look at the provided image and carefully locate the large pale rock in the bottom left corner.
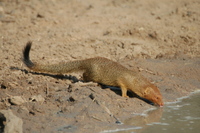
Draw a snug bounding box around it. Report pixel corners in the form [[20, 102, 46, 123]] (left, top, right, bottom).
[[0, 110, 23, 133]]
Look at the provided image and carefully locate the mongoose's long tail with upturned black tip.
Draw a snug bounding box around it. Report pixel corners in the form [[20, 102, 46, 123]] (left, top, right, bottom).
[[23, 41, 84, 74]]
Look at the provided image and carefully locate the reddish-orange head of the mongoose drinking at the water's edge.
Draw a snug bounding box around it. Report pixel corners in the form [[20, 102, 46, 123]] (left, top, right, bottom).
[[143, 85, 164, 107]]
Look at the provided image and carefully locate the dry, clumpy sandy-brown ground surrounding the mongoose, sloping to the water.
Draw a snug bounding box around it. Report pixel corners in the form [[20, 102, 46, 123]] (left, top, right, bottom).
[[0, 0, 200, 133]]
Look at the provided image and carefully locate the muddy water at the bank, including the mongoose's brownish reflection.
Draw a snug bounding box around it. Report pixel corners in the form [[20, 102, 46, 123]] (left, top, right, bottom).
[[101, 91, 200, 133]]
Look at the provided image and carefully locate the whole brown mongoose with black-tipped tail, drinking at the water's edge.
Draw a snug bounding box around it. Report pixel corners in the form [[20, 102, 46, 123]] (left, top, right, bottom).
[[23, 41, 164, 106]]
